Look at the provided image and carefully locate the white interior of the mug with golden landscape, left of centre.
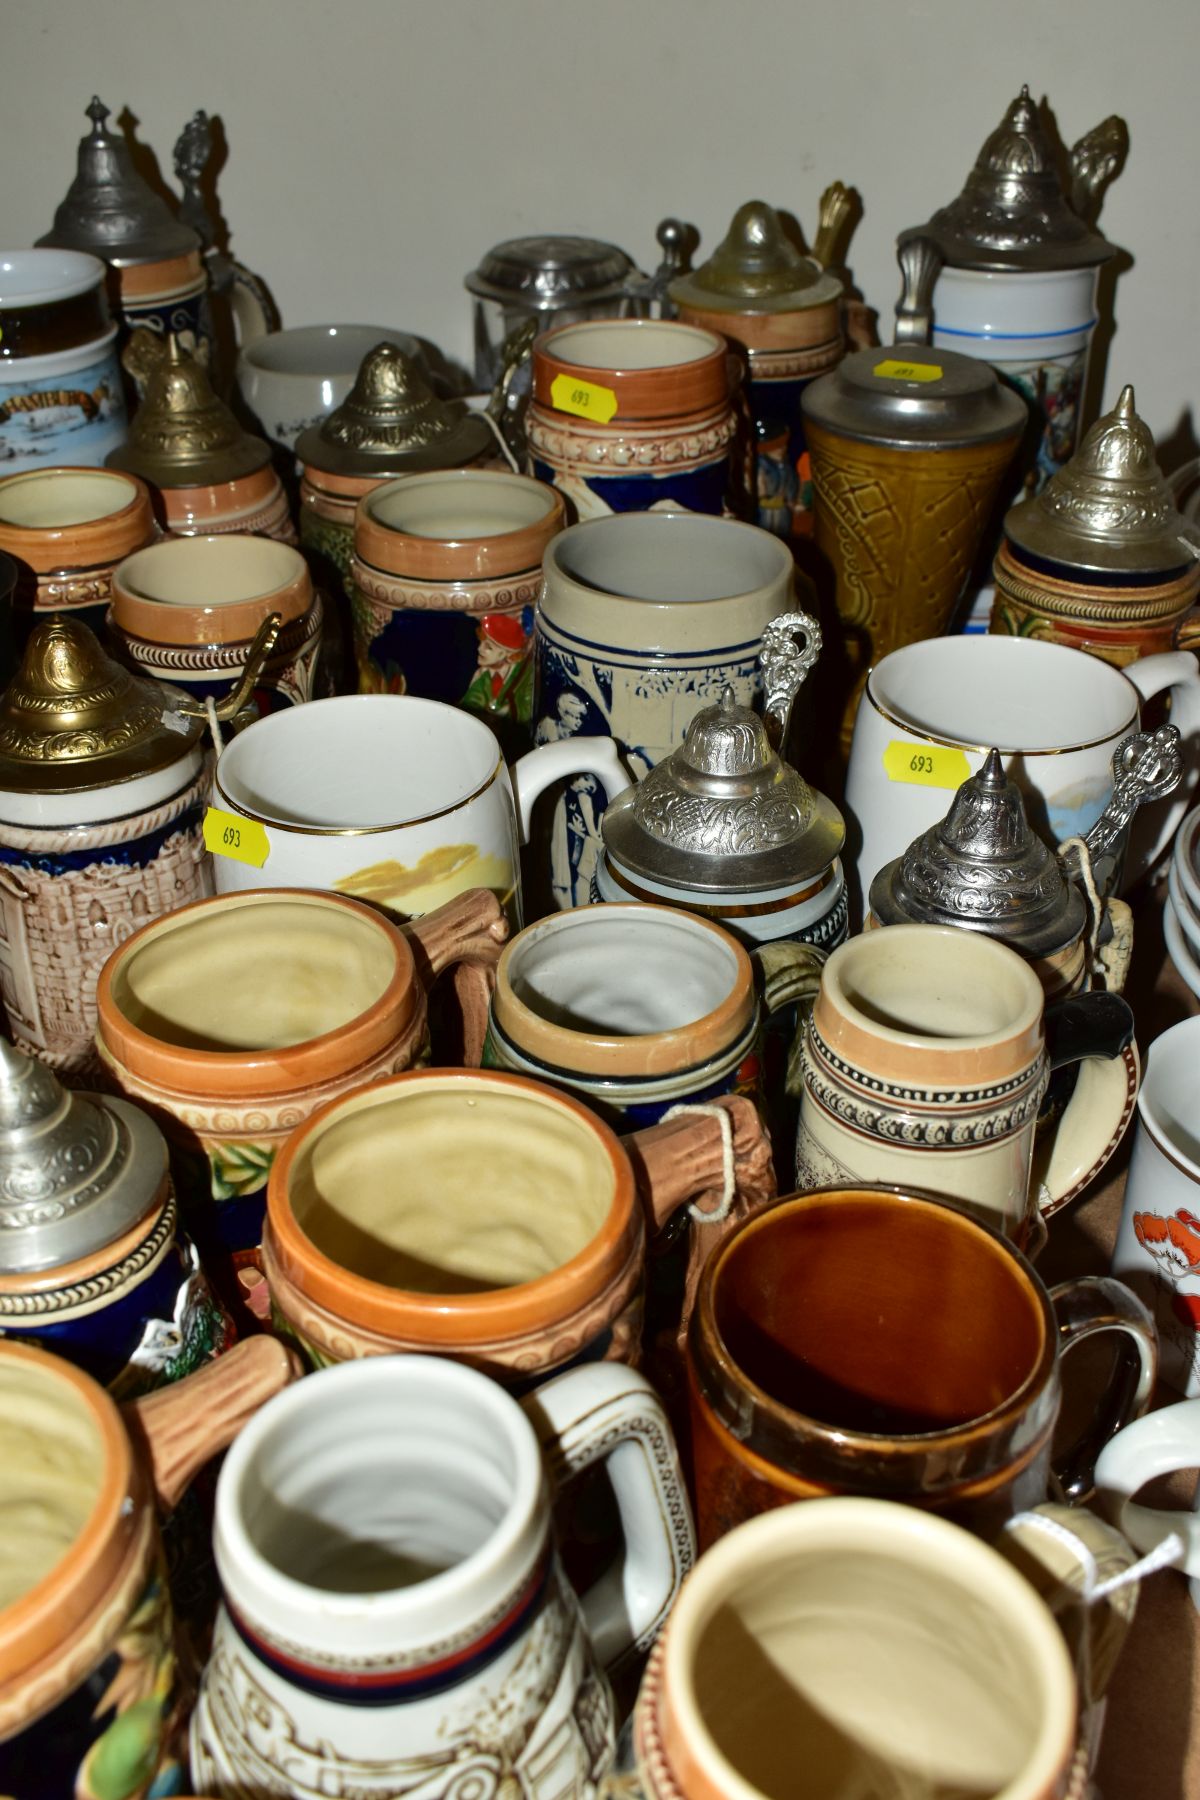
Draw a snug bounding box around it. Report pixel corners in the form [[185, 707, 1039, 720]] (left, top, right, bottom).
[[218, 695, 500, 832]]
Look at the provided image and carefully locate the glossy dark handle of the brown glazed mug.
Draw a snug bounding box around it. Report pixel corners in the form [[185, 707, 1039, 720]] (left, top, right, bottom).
[[1051, 1274, 1159, 1501]]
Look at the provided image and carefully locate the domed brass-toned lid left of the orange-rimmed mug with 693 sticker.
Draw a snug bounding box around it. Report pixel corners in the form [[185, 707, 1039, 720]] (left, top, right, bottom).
[[295, 344, 495, 475]]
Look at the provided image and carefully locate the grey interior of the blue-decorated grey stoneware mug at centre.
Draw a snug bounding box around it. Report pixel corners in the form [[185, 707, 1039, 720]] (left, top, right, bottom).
[[545, 513, 792, 604]]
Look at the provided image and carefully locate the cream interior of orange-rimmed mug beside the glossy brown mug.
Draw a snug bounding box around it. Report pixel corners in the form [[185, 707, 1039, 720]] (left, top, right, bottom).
[[288, 1076, 617, 1294]]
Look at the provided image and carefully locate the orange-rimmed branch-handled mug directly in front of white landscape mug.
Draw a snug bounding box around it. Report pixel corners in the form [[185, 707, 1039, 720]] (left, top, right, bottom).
[[95, 889, 506, 1319]]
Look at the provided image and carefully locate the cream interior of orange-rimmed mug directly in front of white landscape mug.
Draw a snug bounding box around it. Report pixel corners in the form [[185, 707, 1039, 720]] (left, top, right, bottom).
[[112, 893, 396, 1053]]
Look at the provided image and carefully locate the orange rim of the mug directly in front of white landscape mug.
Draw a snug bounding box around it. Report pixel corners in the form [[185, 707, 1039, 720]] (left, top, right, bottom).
[[95, 887, 423, 1100]]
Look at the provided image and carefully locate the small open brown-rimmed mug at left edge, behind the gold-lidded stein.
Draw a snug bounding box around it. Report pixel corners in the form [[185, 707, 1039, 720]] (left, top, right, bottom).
[[0, 468, 158, 643]]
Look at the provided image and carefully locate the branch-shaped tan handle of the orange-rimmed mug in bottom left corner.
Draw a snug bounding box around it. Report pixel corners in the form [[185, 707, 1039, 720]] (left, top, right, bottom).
[[121, 1337, 302, 1512]]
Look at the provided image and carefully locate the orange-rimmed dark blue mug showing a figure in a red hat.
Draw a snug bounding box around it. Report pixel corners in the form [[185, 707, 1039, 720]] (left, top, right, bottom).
[[351, 470, 565, 752]]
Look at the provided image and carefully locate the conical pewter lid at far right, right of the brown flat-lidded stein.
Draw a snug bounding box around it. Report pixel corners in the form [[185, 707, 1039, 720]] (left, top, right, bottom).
[[1004, 387, 1200, 578]]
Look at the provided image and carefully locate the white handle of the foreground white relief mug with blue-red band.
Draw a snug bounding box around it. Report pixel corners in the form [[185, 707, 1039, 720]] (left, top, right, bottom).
[[520, 1363, 696, 1669]]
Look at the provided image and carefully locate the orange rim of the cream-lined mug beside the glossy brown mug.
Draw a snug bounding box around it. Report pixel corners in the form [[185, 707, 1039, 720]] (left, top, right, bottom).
[[266, 1069, 640, 1348]]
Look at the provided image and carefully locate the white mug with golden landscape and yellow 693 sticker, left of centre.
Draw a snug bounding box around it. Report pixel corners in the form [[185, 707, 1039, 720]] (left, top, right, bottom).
[[212, 693, 630, 925]]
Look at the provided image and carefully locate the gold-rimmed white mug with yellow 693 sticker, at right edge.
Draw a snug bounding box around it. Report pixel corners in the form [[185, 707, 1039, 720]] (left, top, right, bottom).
[[844, 637, 1200, 905]]
